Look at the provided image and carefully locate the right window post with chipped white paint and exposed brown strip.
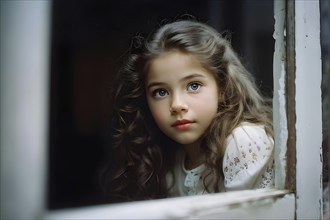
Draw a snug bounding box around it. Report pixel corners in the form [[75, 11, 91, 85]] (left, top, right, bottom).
[[292, 0, 323, 219]]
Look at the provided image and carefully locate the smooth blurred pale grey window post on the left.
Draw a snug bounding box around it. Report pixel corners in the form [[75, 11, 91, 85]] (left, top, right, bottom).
[[0, 1, 51, 219]]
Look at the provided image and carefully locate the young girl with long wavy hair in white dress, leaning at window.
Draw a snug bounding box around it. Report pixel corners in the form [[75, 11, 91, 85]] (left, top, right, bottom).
[[104, 20, 274, 202]]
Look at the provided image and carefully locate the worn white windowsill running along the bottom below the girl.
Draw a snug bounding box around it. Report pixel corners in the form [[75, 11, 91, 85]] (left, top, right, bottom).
[[44, 189, 295, 219]]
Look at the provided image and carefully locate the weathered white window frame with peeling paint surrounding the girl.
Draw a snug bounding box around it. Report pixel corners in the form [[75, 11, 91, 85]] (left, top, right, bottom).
[[0, 0, 322, 219]]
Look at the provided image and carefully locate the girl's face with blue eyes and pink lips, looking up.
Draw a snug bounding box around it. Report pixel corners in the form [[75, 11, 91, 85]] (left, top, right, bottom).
[[146, 51, 219, 145]]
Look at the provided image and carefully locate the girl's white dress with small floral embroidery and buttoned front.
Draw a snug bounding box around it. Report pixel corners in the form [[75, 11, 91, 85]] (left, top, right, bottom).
[[166, 123, 274, 197]]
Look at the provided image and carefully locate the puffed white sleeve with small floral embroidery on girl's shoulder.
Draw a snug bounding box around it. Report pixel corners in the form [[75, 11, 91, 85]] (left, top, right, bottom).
[[223, 124, 274, 191]]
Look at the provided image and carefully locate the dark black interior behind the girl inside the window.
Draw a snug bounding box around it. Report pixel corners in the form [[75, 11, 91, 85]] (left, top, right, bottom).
[[48, 0, 274, 209]]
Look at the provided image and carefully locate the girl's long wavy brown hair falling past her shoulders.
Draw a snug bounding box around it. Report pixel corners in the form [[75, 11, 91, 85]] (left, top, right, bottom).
[[103, 20, 273, 201]]
